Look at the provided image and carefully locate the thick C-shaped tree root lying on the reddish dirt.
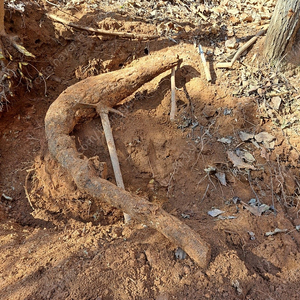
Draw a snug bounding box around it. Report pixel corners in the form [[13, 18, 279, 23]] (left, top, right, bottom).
[[45, 51, 210, 268]]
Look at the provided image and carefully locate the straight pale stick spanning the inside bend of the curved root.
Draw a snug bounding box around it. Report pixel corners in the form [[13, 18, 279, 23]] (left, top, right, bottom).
[[99, 111, 131, 223]]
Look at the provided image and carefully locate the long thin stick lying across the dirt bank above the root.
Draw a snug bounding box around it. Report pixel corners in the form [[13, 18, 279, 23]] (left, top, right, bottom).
[[47, 14, 160, 40]]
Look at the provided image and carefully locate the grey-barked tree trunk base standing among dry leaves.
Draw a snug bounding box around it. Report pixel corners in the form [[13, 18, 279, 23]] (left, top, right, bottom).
[[264, 0, 300, 65]]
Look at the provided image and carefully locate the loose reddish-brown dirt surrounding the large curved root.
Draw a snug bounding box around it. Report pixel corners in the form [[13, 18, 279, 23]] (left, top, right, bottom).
[[0, 1, 300, 300]]
